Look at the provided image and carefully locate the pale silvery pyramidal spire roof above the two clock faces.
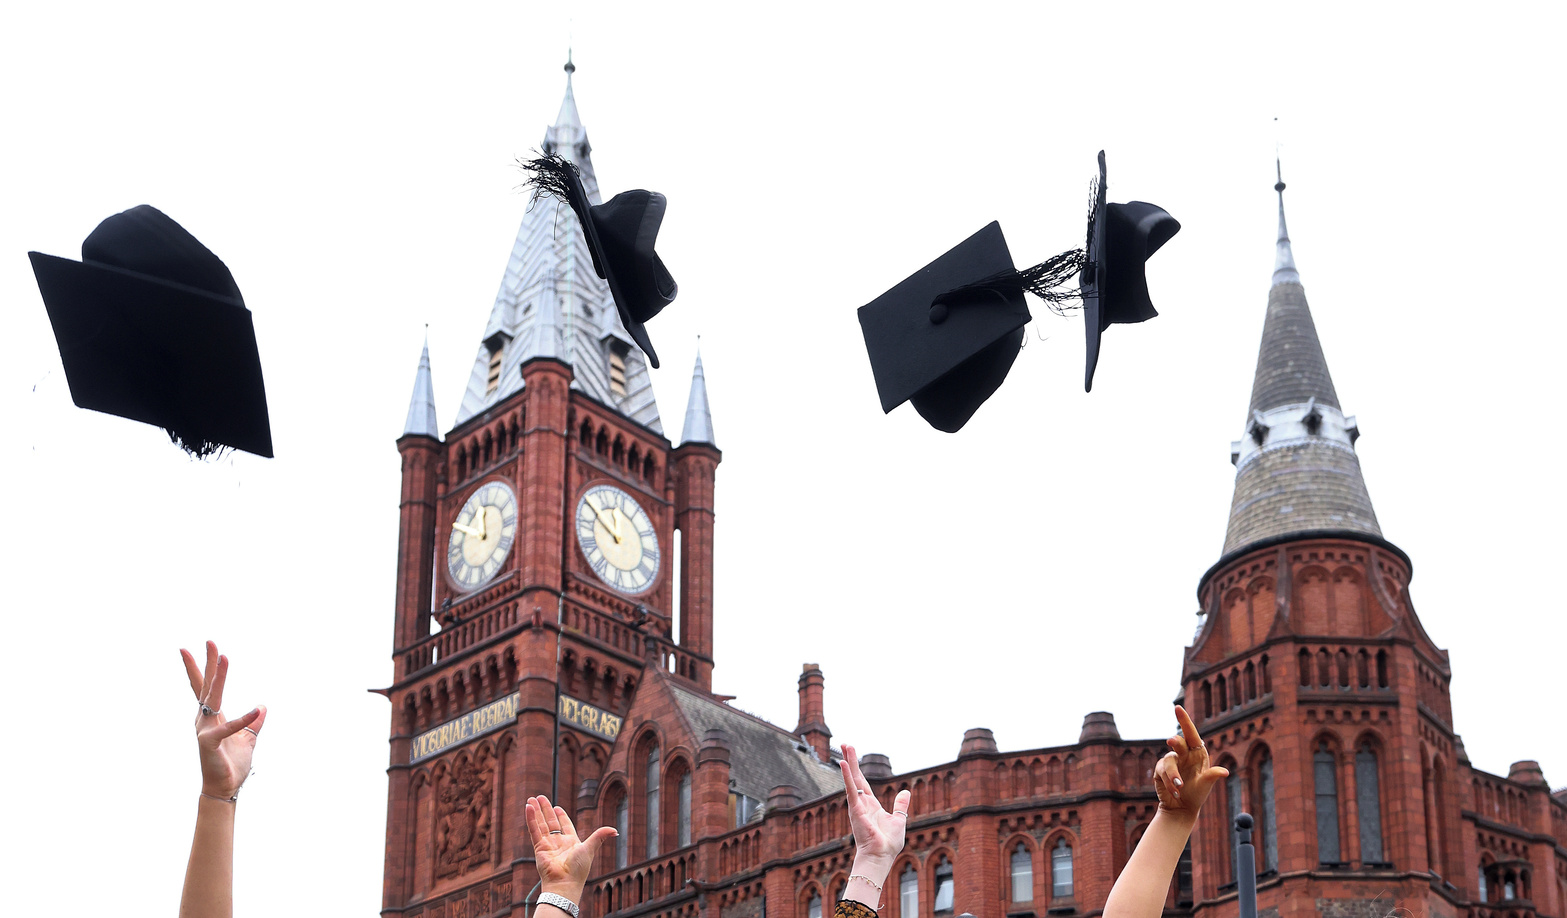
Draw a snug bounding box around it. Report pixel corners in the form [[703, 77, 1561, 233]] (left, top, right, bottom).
[[458, 61, 664, 434]]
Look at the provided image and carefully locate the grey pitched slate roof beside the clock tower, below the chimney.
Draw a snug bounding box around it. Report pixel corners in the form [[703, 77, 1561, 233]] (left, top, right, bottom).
[[669, 680, 843, 802]]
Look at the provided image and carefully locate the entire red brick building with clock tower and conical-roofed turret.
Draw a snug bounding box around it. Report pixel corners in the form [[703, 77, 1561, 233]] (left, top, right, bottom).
[[382, 64, 1567, 918]]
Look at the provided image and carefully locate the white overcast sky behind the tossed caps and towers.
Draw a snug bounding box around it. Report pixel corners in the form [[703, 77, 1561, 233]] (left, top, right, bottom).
[[0, 3, 1567, 916]]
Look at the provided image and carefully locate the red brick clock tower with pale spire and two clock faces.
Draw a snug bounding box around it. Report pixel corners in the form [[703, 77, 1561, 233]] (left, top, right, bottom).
[[378, 55, 721, 918]]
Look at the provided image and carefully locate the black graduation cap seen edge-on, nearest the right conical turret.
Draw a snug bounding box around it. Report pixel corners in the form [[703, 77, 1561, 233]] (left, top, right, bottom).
[[1078, 150, 1180, 392]]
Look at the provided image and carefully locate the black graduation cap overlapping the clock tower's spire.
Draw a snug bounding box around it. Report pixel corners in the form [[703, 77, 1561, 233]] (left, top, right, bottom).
[[522, 154, 680, 370]]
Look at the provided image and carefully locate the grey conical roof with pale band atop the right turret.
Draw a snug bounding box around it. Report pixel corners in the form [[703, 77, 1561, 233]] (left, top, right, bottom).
[[1224, 169, 1382, 555]]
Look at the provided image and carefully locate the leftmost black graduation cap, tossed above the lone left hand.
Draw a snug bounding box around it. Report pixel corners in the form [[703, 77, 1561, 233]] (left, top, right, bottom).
[[28, 204, 273, 457]]
